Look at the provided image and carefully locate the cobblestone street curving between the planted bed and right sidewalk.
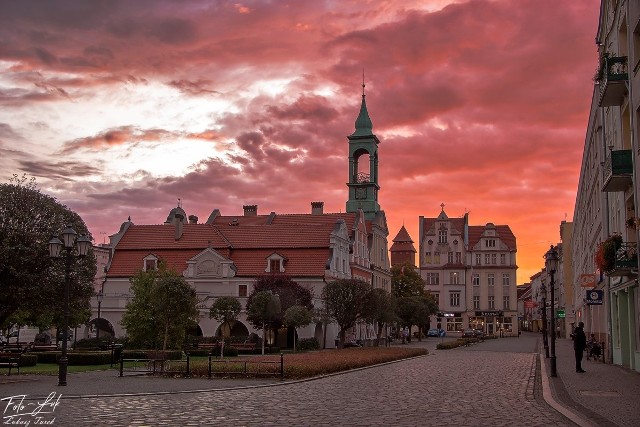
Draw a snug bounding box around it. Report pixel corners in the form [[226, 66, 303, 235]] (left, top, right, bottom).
[[12, 339, 574, 426]]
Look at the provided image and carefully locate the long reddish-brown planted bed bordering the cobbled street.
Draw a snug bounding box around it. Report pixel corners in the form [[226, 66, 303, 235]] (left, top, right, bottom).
[[191, 347, 428, 379]]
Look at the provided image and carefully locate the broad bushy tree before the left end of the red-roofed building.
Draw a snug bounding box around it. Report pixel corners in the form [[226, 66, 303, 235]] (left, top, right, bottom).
[[121, 263, 199, 350]]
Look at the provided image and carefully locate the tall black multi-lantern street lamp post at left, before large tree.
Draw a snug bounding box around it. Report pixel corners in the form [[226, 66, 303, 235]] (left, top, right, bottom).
[[49, 226, 91, 386]]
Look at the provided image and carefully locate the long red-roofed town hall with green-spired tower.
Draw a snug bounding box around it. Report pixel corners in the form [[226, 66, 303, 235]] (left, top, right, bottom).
[[92, 88, 391, 346]]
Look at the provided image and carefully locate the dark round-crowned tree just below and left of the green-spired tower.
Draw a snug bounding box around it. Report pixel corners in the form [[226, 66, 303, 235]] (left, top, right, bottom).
[[322, 279, 371, 347]]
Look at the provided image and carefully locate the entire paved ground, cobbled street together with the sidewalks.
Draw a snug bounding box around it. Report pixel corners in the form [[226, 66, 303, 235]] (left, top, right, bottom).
[[0, 334, 640, 426]]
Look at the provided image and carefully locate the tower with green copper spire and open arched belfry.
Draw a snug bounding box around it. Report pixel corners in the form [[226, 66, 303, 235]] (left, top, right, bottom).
[[347, 77, 380, 220]]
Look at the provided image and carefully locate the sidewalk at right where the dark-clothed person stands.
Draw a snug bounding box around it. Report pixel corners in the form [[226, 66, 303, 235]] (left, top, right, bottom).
[[540, 339, 640, 427]]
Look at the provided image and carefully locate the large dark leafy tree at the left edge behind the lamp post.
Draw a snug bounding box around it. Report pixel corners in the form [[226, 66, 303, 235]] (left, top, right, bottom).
[[0, 175, 96, 328]]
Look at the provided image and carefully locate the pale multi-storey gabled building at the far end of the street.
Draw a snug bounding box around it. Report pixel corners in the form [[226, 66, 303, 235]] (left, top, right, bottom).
[[419, 204, 518, 334]]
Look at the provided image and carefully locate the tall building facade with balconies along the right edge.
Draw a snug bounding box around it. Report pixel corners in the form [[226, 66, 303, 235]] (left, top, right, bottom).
[[571, 0, 640, 371]]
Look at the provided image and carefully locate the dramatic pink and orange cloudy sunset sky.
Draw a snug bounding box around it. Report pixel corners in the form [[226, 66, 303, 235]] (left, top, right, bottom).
[[0, 0, 600, 283]]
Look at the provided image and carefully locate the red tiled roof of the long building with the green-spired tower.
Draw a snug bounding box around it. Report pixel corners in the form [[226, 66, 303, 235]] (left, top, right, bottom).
[[107, 213, 355, 277]]
